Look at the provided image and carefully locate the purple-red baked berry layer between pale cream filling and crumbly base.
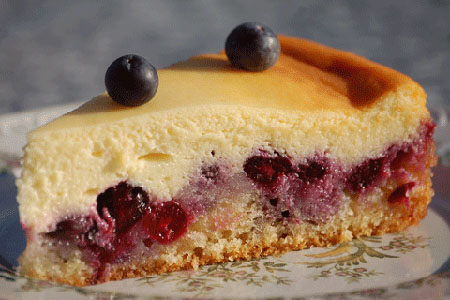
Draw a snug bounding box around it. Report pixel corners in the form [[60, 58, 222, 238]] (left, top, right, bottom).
[[43, 123, 434, 282]]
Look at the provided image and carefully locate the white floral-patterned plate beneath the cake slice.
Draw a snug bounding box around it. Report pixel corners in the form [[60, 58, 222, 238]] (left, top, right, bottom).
[[0, 104, 450, 300]]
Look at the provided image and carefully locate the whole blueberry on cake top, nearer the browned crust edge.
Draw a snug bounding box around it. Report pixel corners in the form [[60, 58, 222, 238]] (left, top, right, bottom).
[[225, 22, 280, 71]]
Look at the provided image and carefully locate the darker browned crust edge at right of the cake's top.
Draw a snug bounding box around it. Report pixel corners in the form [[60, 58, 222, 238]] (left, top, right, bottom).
[[279, 35, 424, 107]]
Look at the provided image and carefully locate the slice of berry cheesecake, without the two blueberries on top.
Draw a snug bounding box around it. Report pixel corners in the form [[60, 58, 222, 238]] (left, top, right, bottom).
[[17, 35, 435, 286]]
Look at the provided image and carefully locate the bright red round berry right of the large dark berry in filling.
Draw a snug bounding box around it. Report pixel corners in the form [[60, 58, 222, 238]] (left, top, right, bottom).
[[143, 201, 188, 245]]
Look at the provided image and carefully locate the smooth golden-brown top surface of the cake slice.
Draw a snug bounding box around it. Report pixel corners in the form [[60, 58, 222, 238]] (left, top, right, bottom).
[[32, 35, 426, 130]]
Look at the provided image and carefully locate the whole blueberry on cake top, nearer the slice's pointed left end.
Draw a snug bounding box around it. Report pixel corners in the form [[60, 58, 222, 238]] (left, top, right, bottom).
[[105, 54, 158, 106]]
